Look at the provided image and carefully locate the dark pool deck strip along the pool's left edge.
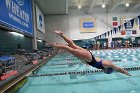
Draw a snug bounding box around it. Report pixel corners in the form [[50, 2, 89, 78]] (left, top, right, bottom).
[[0, 54, 56, 93]]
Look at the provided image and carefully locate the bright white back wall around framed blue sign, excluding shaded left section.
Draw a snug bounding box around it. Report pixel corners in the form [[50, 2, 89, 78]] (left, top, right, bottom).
[[69, 9, 140, 39]]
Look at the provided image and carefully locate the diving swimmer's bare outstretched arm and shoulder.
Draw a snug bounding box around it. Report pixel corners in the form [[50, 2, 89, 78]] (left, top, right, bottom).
[[102, 61, 131, 76]]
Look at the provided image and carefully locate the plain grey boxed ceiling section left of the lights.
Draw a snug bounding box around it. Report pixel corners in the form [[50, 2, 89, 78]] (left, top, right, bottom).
[[35, 0, 68, 15]]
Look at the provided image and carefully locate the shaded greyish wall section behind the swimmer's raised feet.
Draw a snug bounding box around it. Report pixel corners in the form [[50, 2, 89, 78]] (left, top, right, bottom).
[[45, 15, 70, 43]]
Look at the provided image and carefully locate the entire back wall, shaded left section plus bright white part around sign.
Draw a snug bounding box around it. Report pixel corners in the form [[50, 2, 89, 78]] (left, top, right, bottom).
[[45, 9, 140, 42]]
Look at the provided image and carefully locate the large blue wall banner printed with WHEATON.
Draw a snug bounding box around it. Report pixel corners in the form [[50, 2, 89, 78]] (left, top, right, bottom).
[[0, 0, 33, 35]]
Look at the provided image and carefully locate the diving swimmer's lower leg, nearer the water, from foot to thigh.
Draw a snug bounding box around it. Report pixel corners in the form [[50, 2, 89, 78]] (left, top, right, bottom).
[[50, 43, 92, 62]]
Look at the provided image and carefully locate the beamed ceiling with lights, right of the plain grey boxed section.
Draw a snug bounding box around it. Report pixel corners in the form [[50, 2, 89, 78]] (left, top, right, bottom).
[[69, 0, 140, 12]]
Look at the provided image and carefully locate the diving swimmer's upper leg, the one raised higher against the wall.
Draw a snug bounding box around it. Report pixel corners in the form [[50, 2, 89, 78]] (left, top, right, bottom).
[[55, 31, 83, 49]]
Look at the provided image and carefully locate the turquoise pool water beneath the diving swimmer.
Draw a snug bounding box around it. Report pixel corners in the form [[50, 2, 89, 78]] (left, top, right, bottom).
[[17, 48, 140, 93]]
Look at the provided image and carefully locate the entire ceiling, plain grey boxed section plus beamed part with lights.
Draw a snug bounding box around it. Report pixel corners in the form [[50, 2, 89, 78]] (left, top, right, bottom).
[[35, 0, 140, 15]]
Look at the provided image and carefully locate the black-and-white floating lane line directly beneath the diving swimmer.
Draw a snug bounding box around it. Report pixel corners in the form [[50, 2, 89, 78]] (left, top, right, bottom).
[[28, 67, 140, 77]]
